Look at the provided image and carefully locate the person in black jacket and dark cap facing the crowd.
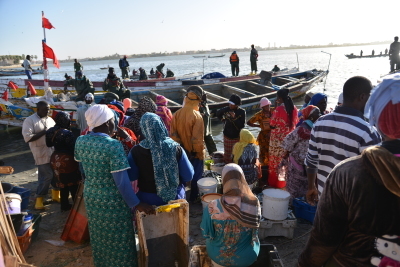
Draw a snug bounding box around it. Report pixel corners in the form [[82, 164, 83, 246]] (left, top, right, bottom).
[[217, 94, 246, 164]]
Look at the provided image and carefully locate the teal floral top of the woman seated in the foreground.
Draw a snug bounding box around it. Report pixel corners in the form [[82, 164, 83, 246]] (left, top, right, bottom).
[[200, 199, 260, 267]]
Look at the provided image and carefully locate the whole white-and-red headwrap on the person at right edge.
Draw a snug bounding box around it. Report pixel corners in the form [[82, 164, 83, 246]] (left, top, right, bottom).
[[364, 73, 400, 139]]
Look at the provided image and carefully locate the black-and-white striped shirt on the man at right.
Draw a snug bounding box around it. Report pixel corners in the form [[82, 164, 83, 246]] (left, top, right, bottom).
[[305, 107, 381, 194]]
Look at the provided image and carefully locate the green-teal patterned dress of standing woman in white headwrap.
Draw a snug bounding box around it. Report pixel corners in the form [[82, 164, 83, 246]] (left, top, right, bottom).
[[75, 134, 138, 267]]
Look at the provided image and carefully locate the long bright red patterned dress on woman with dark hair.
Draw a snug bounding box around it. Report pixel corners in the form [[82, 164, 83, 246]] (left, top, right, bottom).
[[268, 104, 298, 188]]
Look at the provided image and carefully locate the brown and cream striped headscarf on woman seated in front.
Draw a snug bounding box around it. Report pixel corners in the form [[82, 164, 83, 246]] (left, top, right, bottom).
[[221, 163, 261, 228]]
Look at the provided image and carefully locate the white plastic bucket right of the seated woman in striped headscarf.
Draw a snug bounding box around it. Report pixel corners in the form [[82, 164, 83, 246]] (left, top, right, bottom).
[[262, 188, 290, 221]]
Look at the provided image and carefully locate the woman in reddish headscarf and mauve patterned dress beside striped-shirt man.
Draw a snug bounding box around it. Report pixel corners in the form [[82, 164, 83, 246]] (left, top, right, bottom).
[[282, 105, 320, 199]]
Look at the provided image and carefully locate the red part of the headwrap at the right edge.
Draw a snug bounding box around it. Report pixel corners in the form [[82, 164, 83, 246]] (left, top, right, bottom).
[[378, 101, 400, 139]]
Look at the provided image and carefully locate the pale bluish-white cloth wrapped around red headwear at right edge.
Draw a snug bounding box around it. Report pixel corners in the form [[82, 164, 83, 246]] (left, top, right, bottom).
[[364, 73, 400, 126]]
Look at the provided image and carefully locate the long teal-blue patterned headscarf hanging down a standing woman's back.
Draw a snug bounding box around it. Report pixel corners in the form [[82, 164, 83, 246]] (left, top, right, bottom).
[[139, 112, 179, 202]]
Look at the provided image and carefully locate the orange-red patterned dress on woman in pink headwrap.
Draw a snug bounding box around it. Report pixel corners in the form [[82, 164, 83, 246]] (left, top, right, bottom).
[[249, 108, 274, 166]]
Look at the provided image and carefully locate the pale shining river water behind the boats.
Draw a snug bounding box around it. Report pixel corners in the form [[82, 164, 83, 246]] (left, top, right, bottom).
[[0, 44, 390, 154]]
